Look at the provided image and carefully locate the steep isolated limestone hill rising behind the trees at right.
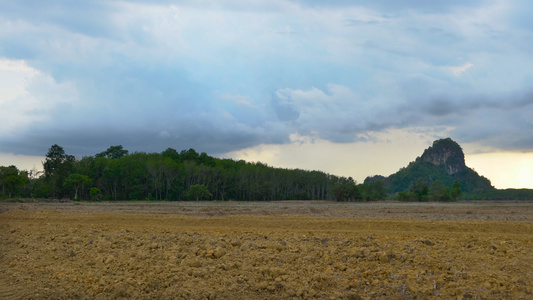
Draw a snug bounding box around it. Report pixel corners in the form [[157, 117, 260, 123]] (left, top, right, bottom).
[[365, 138, 494, 193]]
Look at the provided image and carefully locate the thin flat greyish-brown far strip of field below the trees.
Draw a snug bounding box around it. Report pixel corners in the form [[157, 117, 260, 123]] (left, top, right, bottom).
[[0, 201, 533, 222]]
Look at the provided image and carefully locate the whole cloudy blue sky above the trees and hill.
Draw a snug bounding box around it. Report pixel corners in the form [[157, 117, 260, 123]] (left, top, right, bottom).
[[0, 0, 533, 188]]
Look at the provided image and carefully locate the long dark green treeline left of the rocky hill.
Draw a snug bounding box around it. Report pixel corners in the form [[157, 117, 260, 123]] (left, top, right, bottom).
[[0, 145, 386, 201]]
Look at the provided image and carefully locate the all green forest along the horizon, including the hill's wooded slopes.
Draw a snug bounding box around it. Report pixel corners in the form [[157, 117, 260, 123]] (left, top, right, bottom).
[[0, 145, 533, 201]]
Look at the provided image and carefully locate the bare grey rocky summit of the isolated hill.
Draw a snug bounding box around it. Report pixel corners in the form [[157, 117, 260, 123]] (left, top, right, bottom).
[[421, 138, 467, 175]]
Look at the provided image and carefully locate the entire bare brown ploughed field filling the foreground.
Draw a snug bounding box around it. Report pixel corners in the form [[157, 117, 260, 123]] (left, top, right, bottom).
[[0, 201, 533, 299]]
